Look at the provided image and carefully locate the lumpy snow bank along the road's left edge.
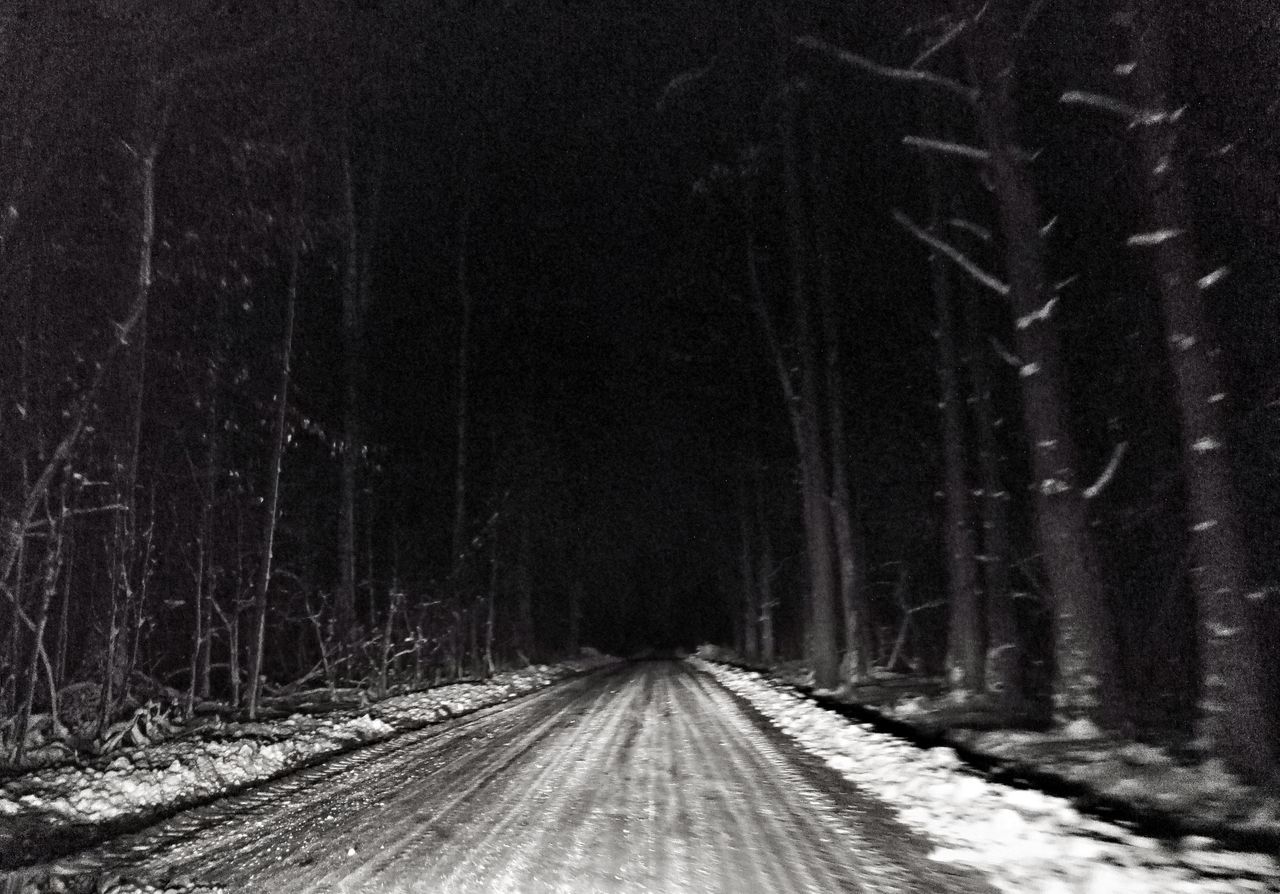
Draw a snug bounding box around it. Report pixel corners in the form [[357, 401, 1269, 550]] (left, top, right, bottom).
[[0, 654, 617, 868]]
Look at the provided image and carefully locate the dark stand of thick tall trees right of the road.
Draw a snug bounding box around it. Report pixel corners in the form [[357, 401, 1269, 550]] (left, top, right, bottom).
[[663, 1, 1277, 777]]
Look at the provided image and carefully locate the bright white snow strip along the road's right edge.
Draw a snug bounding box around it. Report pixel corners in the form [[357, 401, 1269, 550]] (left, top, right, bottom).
[[690, 657, 1280, 894]]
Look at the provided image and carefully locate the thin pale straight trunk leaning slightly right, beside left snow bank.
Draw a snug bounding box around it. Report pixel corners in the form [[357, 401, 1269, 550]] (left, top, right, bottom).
[[241, 170, 302, 720]]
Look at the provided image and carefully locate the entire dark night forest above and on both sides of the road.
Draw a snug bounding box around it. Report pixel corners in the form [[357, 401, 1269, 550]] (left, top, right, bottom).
[[0, 0, 1280, 777]]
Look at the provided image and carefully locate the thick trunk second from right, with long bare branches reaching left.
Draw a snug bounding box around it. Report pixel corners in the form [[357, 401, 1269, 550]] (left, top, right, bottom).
[[961, 0, 1123, 726]]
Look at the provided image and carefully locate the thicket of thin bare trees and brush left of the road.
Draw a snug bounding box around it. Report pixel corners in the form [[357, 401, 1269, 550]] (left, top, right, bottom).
[[0, 4, 555, 761]]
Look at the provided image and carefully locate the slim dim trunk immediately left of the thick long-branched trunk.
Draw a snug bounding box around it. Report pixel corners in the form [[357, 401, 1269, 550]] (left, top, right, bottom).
[[965, 293, 1025, 708]]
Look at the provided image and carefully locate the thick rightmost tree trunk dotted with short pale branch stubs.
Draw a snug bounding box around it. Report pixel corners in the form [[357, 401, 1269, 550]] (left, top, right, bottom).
[[1130, 0, 1275, 777]]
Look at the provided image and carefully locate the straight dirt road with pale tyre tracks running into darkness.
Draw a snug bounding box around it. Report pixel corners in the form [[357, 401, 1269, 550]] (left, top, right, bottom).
[[17, 662, 989, 894]]
